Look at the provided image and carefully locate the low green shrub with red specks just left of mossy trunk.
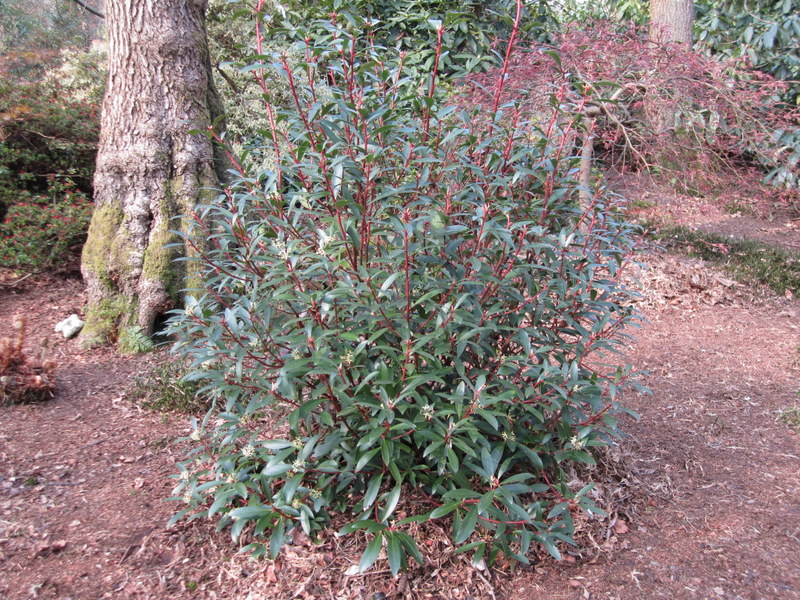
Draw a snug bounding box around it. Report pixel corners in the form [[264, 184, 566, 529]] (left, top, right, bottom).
[[0, 179, 92, 270]]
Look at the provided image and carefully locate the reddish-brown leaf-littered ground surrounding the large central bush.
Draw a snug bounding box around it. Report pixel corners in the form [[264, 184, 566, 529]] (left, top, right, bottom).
[[0, 179, 800, 600]]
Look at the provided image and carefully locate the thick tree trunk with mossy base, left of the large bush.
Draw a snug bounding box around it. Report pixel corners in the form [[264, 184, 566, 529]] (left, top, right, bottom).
[[81, 0, 221, 344]]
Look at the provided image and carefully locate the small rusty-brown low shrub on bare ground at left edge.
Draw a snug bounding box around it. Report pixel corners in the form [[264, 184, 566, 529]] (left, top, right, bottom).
[[0, 318, 55, 406]]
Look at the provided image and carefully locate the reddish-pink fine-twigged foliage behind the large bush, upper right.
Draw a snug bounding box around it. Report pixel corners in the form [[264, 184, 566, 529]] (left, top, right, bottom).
[[459, 22, 798, 195]]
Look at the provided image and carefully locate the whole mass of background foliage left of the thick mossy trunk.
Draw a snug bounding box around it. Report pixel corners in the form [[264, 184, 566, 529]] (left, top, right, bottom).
[[0, 2, 106, 270]]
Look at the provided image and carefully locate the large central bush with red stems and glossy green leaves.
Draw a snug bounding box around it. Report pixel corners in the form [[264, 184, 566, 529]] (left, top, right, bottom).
[[170, 5, 636, 573]]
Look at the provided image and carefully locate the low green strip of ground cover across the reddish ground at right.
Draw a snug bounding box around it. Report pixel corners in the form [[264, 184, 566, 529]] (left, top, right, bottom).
[[656, 226, 800, 294]]
